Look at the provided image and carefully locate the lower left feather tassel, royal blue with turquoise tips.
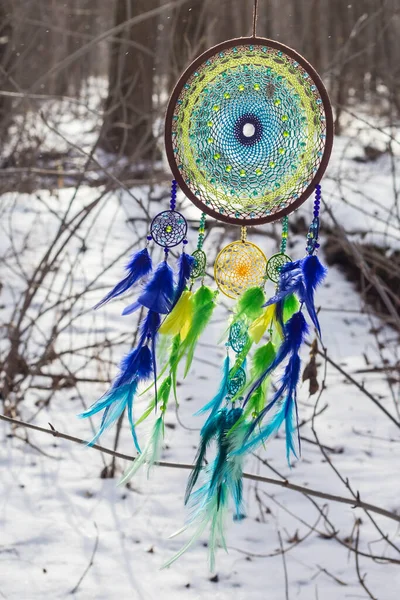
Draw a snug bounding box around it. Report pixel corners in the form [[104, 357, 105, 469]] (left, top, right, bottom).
[[78, 345, 153, 452]]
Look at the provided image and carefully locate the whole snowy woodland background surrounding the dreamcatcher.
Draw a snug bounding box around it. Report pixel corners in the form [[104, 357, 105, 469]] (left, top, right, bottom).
[[0, 0, 400, 600]]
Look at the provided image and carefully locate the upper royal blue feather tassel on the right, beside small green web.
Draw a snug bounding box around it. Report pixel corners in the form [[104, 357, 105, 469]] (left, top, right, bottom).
[[264, 255, 327, 337]]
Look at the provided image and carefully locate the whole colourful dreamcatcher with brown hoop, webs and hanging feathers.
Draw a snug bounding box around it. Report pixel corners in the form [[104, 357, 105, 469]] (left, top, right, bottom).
[[79, 1, 333, 567]]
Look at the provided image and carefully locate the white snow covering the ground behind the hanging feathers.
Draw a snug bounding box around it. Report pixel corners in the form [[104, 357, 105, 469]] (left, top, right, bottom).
[[0, 109, 400, 600]]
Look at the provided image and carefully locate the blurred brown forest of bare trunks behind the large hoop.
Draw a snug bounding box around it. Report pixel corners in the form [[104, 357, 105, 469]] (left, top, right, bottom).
[[0, 0, 400, 173]]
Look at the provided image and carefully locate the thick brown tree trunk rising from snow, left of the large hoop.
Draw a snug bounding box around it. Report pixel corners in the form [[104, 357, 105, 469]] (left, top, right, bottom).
[[99, 0, 158, 160]]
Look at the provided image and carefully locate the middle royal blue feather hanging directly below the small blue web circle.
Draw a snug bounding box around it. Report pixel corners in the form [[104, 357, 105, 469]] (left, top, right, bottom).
[[122, 260, 174, 315]]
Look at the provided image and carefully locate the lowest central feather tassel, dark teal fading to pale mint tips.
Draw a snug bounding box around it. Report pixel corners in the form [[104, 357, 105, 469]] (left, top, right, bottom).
[[163, 408, 245, 571]]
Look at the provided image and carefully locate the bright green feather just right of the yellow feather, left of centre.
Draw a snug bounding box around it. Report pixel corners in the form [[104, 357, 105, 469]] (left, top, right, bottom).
[[178, 285, 216, 377]]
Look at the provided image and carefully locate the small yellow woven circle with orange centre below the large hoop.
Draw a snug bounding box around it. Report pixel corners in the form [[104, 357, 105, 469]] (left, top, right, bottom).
[[214, 241, 267, 298]]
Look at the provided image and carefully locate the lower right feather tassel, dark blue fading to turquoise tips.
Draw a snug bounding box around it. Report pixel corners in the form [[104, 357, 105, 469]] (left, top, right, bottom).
[[240, 312, 308, 462]]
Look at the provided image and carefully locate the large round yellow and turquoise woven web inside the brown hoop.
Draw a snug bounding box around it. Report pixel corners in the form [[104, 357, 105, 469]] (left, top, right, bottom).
[[172, 46, 326, 219]]
